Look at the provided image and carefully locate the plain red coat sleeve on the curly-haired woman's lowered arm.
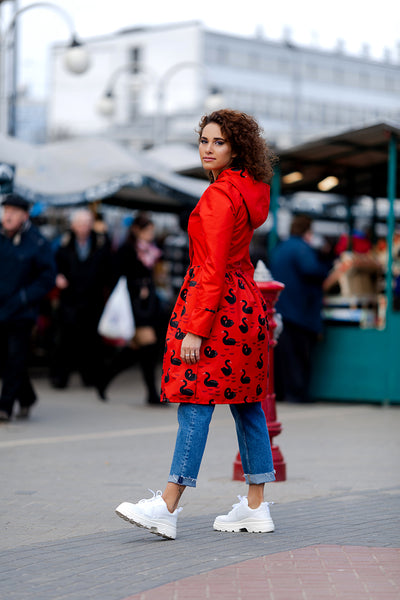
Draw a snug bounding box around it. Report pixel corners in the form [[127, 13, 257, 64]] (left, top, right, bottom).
[[187, 186, 236, 337]]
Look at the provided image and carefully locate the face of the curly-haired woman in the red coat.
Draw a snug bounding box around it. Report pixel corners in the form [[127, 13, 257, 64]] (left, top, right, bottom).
[[199, 123, 236, 179]]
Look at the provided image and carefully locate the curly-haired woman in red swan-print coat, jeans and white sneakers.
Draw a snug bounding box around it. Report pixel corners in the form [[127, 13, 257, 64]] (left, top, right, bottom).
[[116, 110, 275, 539]]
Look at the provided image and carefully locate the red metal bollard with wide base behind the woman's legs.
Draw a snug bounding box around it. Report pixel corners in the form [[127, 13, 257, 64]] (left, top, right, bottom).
[[233, 281, 286, 481]]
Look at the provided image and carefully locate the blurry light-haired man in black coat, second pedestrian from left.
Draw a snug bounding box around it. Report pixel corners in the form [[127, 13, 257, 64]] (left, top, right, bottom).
[[51, 208, 111, 388]]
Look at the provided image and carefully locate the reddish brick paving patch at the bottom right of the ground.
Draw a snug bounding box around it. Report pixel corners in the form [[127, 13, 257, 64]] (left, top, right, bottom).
[[125, 545, 400, 600]]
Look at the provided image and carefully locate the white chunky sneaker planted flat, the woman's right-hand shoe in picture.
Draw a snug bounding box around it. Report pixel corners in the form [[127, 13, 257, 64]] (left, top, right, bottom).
[[214, 496, 275, 533]]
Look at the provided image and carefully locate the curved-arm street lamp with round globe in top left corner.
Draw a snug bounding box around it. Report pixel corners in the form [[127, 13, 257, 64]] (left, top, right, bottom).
[[2, 2, 89, 136]]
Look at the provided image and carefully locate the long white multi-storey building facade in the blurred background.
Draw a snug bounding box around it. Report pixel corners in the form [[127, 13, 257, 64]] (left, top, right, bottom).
[[48, 21, 400, 148]]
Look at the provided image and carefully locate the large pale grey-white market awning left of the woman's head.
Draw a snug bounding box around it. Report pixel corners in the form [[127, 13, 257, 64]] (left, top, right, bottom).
[[0, 136, 206, 212]]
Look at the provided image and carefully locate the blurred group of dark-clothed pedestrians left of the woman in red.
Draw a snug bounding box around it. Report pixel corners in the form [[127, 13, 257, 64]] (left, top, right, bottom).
[[0, 194, 188, 421]]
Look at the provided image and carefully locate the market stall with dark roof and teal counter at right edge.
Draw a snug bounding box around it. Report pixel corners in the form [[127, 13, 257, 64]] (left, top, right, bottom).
[[272, 123, 400, 403]]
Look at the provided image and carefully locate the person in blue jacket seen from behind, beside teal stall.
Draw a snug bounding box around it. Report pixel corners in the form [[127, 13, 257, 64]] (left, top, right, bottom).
[[270, 215, 331, 402]]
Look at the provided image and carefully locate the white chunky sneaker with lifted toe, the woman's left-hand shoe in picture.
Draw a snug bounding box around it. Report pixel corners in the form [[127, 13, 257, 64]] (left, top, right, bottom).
[[115, 490, 182, 540]]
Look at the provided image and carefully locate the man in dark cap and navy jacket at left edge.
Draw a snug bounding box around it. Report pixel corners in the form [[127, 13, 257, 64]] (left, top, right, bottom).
[[0, 194, 56, 423]]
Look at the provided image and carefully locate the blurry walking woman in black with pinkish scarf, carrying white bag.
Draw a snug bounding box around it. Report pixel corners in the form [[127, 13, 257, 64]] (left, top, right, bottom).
[[98, 213, 161, 406]]
